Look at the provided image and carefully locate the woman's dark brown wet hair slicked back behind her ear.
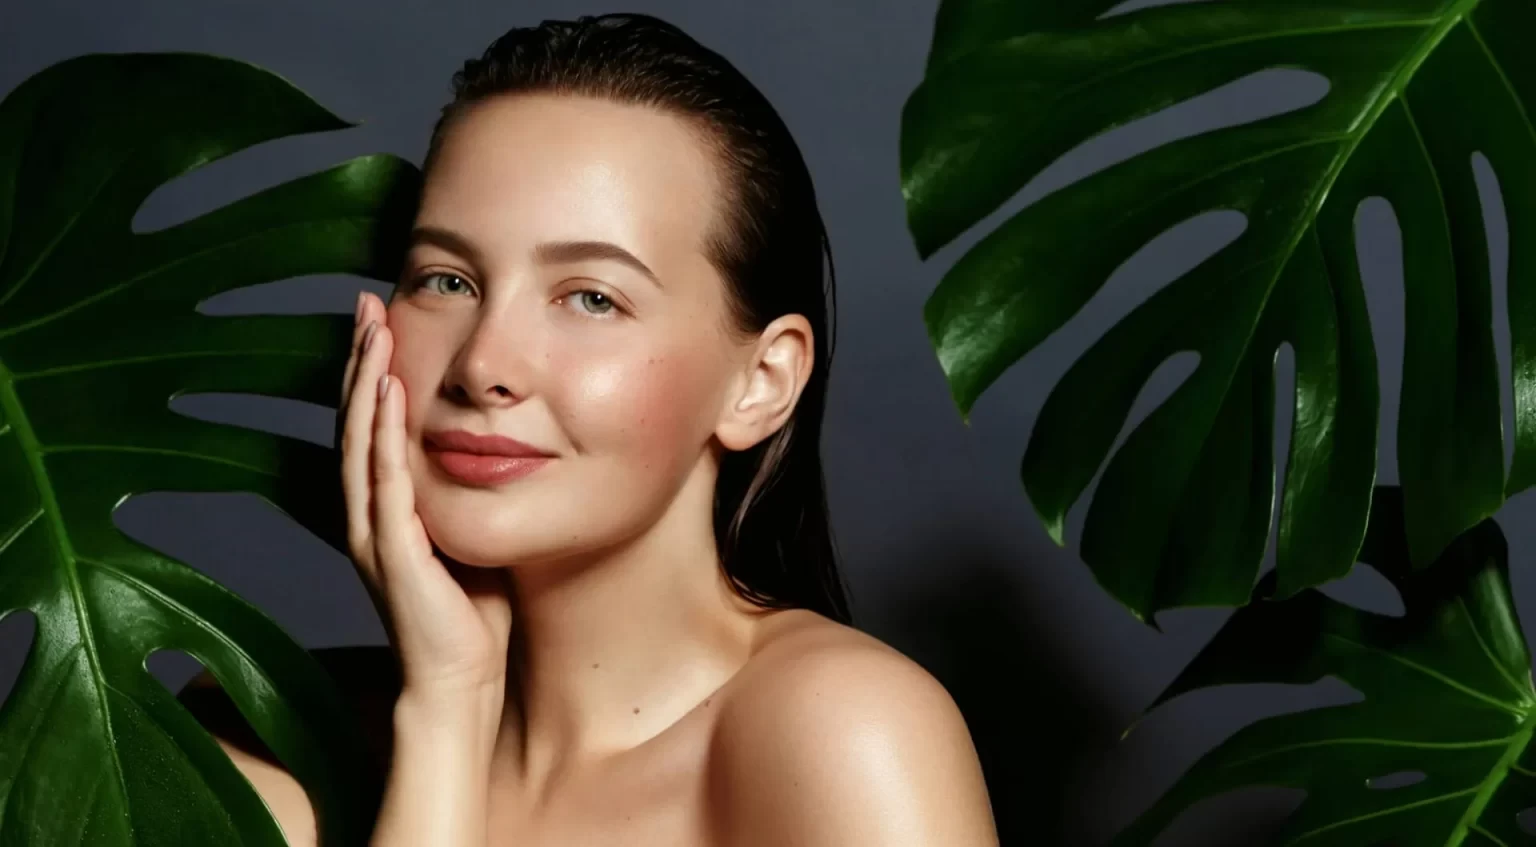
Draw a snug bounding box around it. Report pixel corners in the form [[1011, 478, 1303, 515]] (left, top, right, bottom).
[[425, 14, 851, 623]]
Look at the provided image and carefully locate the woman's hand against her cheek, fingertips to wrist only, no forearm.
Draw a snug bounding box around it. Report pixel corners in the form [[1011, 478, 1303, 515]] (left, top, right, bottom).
[[338, 292, 511, 707]]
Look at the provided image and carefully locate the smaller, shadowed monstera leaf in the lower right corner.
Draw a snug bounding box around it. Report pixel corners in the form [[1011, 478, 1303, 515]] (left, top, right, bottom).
[[1114, 489, 1536, 847]]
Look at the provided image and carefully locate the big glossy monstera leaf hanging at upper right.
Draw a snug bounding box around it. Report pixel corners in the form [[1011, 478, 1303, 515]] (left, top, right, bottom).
[[902, 0, 1536, 619]]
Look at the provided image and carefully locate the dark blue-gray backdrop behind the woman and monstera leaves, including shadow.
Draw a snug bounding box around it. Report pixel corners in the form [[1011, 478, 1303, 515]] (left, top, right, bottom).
[[0, 0, 1536, 845]]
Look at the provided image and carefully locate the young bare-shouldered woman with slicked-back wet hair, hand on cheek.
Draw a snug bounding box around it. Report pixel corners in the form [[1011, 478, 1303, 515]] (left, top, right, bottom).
[[185, 15, 997, 847]]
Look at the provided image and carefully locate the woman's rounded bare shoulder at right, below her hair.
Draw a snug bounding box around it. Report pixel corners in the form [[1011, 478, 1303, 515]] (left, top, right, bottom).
[[710, 612, 997, 847]]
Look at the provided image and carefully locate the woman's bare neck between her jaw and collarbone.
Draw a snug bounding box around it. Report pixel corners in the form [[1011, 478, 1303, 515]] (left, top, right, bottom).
[[496, 461, 760, 787]]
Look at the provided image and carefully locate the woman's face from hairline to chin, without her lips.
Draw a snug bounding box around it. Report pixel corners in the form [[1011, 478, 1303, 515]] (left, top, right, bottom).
[[387, 95, 768, 566]]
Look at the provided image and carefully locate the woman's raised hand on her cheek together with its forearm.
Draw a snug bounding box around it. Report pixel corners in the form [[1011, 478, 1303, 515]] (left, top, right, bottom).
[[339, 292, 511, 847]]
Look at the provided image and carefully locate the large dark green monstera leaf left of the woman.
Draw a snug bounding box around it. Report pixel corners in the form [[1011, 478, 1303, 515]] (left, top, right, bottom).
[[0, 54, 416, 847]]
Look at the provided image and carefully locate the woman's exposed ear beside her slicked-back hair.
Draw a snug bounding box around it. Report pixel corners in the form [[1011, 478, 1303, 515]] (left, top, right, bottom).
[[714, 315, 816, 450]]
